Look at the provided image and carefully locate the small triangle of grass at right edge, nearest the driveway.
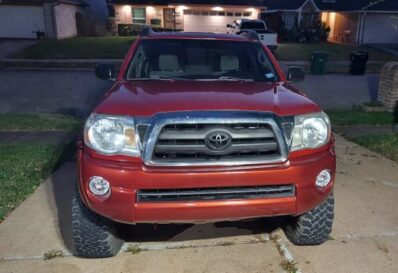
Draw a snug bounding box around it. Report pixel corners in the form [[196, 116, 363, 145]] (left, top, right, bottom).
[[350, 134, 398, 162]]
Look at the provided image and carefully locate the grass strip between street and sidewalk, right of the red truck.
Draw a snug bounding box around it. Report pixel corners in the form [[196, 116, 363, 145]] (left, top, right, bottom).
[[326, 107, 393, 126]]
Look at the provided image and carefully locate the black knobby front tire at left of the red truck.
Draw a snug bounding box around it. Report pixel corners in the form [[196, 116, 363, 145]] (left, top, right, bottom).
[[72, 187, 123, 258]]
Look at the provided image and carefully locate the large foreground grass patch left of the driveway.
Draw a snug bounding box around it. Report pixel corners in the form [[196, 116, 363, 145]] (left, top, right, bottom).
[[0, 144, 60, 222]]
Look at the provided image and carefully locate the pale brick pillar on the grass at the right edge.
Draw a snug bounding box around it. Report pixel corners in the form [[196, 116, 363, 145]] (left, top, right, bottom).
[[377, 62, 398, 111]]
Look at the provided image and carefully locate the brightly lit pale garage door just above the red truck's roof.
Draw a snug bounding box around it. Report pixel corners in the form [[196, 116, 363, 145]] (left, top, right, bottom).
[[184, 12, 249, 33]]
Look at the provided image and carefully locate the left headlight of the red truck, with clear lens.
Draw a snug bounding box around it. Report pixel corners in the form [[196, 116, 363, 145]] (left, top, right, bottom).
[[84, 114, 140, 155]]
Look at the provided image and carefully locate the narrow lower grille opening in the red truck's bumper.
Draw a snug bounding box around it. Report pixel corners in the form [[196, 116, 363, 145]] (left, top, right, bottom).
[[137, 185, 295, 202]]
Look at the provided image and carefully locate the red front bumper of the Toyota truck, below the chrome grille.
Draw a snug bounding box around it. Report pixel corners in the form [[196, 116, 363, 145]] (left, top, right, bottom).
[[77, 143, 336, 223]]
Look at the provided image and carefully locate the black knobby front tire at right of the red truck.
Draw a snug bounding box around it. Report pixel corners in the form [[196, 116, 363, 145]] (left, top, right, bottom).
[[284, 194, 334, 245]]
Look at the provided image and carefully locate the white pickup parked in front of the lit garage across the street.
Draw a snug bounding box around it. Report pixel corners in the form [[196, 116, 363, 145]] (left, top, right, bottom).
[[227, 19, 278, 51]]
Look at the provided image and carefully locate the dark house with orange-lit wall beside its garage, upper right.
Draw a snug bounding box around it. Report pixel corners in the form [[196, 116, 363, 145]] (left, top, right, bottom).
[[261, 0, 398, 44]]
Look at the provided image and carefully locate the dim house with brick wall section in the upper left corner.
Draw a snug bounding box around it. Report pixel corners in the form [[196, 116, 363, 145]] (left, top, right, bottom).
[[0, 0, 108, 39]]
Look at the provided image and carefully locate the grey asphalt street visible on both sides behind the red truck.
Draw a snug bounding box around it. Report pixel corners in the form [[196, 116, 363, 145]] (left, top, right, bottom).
[[0, 70, 378, 113]]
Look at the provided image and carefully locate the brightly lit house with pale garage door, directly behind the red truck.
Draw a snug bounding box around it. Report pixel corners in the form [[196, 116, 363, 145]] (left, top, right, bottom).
[[110, 0, 263, 33]]
